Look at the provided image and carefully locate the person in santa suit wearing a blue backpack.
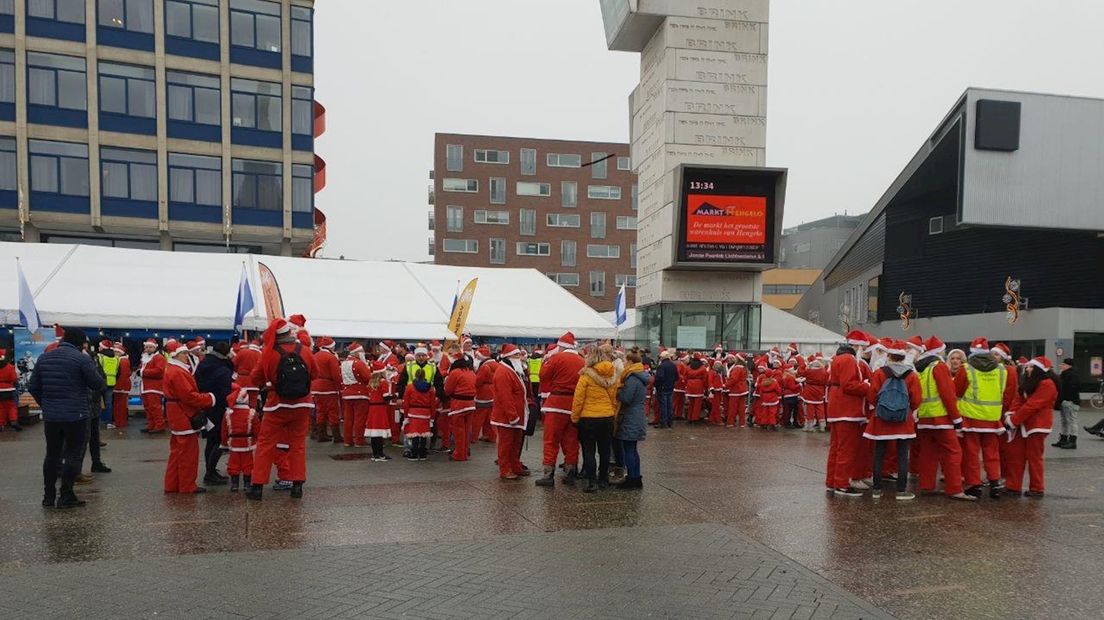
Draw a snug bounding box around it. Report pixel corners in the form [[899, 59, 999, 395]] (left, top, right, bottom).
[[862, 341, 923, 501]]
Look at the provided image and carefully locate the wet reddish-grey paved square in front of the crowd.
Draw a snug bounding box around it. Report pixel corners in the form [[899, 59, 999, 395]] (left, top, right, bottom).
[[0, 410, 1104, 619]]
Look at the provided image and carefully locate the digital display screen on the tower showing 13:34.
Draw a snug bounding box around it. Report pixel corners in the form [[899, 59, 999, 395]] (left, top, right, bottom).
[[677, 167, 783, 265]]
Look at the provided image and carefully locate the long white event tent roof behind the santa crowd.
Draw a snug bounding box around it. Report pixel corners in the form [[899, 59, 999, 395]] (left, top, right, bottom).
[[0, 243, 615, 340]]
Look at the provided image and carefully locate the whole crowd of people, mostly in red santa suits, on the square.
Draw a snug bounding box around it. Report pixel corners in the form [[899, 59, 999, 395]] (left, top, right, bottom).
[[19, 316, 1079, 507]]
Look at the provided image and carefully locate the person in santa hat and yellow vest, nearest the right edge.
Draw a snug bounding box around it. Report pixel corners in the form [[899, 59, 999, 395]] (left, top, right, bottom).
[[955, 338, 1012, 499]]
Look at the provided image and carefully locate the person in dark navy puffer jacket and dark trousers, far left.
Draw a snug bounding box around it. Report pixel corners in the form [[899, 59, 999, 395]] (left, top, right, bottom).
[[28, 328, 106, 509]]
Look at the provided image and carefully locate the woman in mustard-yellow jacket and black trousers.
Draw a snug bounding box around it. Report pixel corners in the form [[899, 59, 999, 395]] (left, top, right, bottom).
[[571, 344, 617, 493]]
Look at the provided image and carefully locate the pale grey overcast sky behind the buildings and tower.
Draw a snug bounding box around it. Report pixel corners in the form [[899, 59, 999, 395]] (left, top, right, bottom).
[[315, 0, 1104, 260]]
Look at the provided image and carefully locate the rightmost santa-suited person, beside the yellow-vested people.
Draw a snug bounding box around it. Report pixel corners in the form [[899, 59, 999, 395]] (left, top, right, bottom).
[[1004, 356, 1061, 498]]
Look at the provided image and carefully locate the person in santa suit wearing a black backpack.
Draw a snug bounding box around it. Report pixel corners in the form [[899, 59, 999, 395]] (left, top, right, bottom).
[[245, 318, 316, 500]]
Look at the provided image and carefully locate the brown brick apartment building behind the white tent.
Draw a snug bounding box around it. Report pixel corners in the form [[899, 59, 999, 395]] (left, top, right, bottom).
[[429, 133, 637, 311]]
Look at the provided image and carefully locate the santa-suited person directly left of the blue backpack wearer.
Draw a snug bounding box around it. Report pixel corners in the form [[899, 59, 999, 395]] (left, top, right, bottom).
[[825, 330, 870, 498]]
